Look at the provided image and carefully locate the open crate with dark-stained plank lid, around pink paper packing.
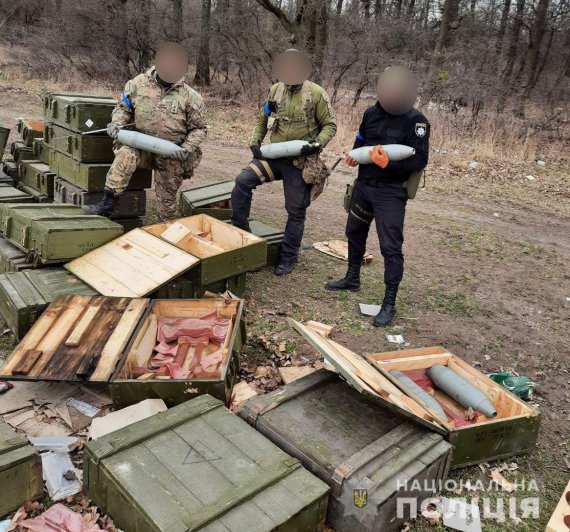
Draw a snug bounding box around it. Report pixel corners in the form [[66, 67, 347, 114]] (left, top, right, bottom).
[[0, 295, 244, 408]]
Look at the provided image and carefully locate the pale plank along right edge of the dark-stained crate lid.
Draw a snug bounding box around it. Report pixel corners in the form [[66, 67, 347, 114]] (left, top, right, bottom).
[[89, 299, 150, 382]]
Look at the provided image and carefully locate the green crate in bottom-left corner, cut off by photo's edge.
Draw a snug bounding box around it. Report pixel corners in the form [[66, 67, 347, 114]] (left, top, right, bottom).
[[0, 420, 44, 518]]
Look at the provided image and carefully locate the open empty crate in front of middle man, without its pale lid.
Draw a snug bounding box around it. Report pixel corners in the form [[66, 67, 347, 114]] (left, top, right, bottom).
[[143, 214, 267, 285]]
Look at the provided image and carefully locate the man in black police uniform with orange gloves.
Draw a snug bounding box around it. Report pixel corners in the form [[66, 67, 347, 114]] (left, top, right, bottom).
[[325, 67, 430, 327]]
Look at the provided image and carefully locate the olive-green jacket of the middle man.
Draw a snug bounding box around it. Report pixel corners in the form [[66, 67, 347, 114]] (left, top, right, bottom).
[[250, 81, 336, 146]]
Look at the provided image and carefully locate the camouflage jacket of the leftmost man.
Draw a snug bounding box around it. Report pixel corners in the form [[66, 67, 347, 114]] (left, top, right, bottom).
[[112, 67, 208, 152]]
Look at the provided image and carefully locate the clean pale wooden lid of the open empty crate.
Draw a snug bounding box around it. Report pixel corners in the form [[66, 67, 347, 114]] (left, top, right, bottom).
[[65, 229, 200, 297]]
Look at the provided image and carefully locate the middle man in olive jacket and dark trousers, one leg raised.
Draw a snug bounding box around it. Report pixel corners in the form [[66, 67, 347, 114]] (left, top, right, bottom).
[[232, 50, 336, 275]]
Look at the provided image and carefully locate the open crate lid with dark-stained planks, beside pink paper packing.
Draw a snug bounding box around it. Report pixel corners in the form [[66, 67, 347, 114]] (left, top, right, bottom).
[[0, 296, 149, 382]]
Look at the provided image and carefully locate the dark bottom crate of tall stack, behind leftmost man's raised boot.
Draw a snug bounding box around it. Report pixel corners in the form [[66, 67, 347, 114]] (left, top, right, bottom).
[[54, 177, 146, 220]]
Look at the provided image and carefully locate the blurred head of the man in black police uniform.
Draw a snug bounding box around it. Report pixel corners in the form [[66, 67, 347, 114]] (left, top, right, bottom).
[[378, 67, 418, 115]]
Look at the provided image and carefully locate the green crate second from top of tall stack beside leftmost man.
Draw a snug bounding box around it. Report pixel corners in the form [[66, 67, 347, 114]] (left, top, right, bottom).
[[44, 124, 115, 163]]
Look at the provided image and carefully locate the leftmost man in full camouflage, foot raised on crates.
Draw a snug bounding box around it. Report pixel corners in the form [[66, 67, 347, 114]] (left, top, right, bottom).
[[88, 43, 207, 220]]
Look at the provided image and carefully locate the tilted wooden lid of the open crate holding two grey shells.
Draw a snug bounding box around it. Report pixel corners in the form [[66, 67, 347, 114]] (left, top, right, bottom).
[[287, 318, 448, 434]]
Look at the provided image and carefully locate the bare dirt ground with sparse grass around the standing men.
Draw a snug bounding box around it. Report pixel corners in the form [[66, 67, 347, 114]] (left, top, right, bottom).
[[0, 87, 570, 531]]
